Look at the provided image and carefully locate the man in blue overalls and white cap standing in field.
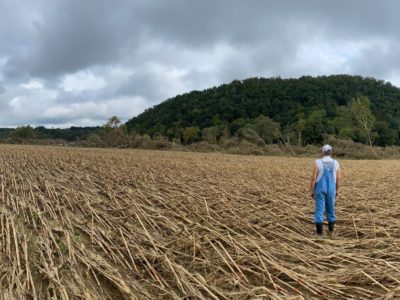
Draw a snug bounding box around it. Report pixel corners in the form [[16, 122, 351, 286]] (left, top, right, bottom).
[[310, 145, 341, 237]]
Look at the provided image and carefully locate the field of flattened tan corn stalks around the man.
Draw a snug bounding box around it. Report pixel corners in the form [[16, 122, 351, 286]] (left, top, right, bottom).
[[0, 146, 400, 299]]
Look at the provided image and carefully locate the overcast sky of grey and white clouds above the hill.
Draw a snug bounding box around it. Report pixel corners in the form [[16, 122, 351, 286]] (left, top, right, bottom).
[[0, 0, 400, 127]]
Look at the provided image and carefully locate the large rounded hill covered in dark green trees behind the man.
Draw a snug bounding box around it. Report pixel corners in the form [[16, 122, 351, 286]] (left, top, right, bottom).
[[126, 75, 400, 145]]
